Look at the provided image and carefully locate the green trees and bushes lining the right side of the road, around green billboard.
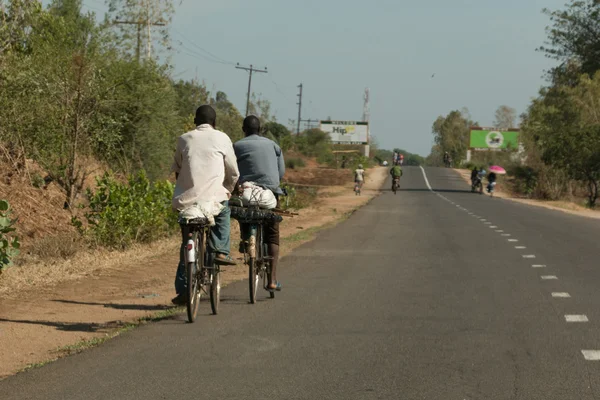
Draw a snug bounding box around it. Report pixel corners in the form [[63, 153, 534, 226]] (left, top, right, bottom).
[[427, 0, 600, 208]]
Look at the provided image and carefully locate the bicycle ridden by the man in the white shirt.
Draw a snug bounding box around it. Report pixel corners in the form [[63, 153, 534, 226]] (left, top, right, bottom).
[[179, 218, 221, 323]]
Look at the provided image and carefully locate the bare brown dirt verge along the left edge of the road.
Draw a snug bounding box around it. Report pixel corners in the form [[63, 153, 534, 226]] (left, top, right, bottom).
[[0, 168, 387, 378]]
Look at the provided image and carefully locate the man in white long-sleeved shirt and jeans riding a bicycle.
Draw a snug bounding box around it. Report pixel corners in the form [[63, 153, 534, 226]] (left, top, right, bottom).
[[172, 105, 240, 305]]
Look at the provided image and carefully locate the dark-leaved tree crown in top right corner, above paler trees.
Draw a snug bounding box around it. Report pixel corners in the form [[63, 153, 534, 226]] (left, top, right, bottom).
[[538, 0, 600, 83]]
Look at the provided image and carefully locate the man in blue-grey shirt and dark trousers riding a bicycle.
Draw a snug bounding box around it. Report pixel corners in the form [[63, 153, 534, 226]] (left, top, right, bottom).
[[233, 115, 285, 290]]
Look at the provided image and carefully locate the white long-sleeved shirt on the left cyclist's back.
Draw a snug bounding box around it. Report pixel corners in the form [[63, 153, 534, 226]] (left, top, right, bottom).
[[171, 124, 240, 211]]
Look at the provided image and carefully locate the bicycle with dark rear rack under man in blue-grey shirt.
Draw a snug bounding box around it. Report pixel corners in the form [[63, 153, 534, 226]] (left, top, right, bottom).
[[230, 206, 283, 304]]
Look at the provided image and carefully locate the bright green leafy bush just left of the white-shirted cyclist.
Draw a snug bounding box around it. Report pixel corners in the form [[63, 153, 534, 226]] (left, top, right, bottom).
[[73, 171, 177, 248]]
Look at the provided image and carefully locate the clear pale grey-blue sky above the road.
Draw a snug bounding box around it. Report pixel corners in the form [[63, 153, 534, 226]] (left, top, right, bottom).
[[76, 0, 566, 156]]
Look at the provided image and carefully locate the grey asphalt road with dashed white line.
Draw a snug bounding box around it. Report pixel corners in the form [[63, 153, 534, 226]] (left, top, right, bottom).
[[0, 168, 600, 400]]
